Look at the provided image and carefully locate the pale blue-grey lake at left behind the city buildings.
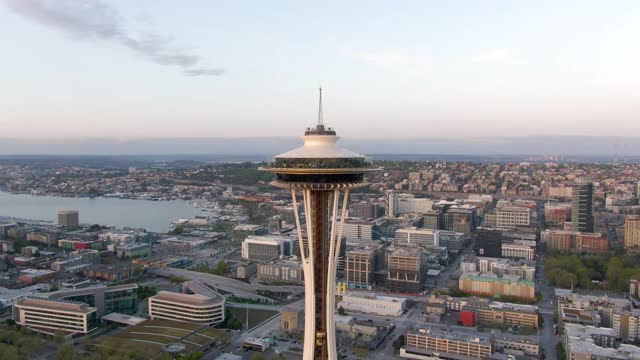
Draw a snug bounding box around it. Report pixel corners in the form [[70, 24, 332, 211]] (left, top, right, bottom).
[[0, 191, 202, 232]]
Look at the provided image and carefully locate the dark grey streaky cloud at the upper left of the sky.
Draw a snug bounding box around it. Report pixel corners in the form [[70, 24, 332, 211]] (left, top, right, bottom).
[[6, 0, 225, 76]]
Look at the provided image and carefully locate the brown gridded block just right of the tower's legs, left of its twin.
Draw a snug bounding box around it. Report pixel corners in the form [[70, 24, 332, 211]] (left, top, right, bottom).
[[344, 246, 380, 289]]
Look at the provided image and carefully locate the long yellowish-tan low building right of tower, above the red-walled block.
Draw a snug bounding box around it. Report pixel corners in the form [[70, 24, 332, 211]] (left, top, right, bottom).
[[458, 273, 535, 300]]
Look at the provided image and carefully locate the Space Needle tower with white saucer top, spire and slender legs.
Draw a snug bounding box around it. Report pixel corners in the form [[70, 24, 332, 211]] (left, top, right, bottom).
[[262, 88, 379, 360]]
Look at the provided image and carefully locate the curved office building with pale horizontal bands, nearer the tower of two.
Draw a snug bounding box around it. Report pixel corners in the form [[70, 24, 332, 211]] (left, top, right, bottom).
[[148, 281, 225, 326]]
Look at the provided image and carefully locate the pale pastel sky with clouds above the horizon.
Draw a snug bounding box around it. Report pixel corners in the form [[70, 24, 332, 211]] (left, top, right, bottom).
[[0, 0, 640, 139]]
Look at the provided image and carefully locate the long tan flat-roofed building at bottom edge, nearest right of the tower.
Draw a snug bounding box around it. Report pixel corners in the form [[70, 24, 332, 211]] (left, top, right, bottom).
[[400, 328, 494, 359]]
